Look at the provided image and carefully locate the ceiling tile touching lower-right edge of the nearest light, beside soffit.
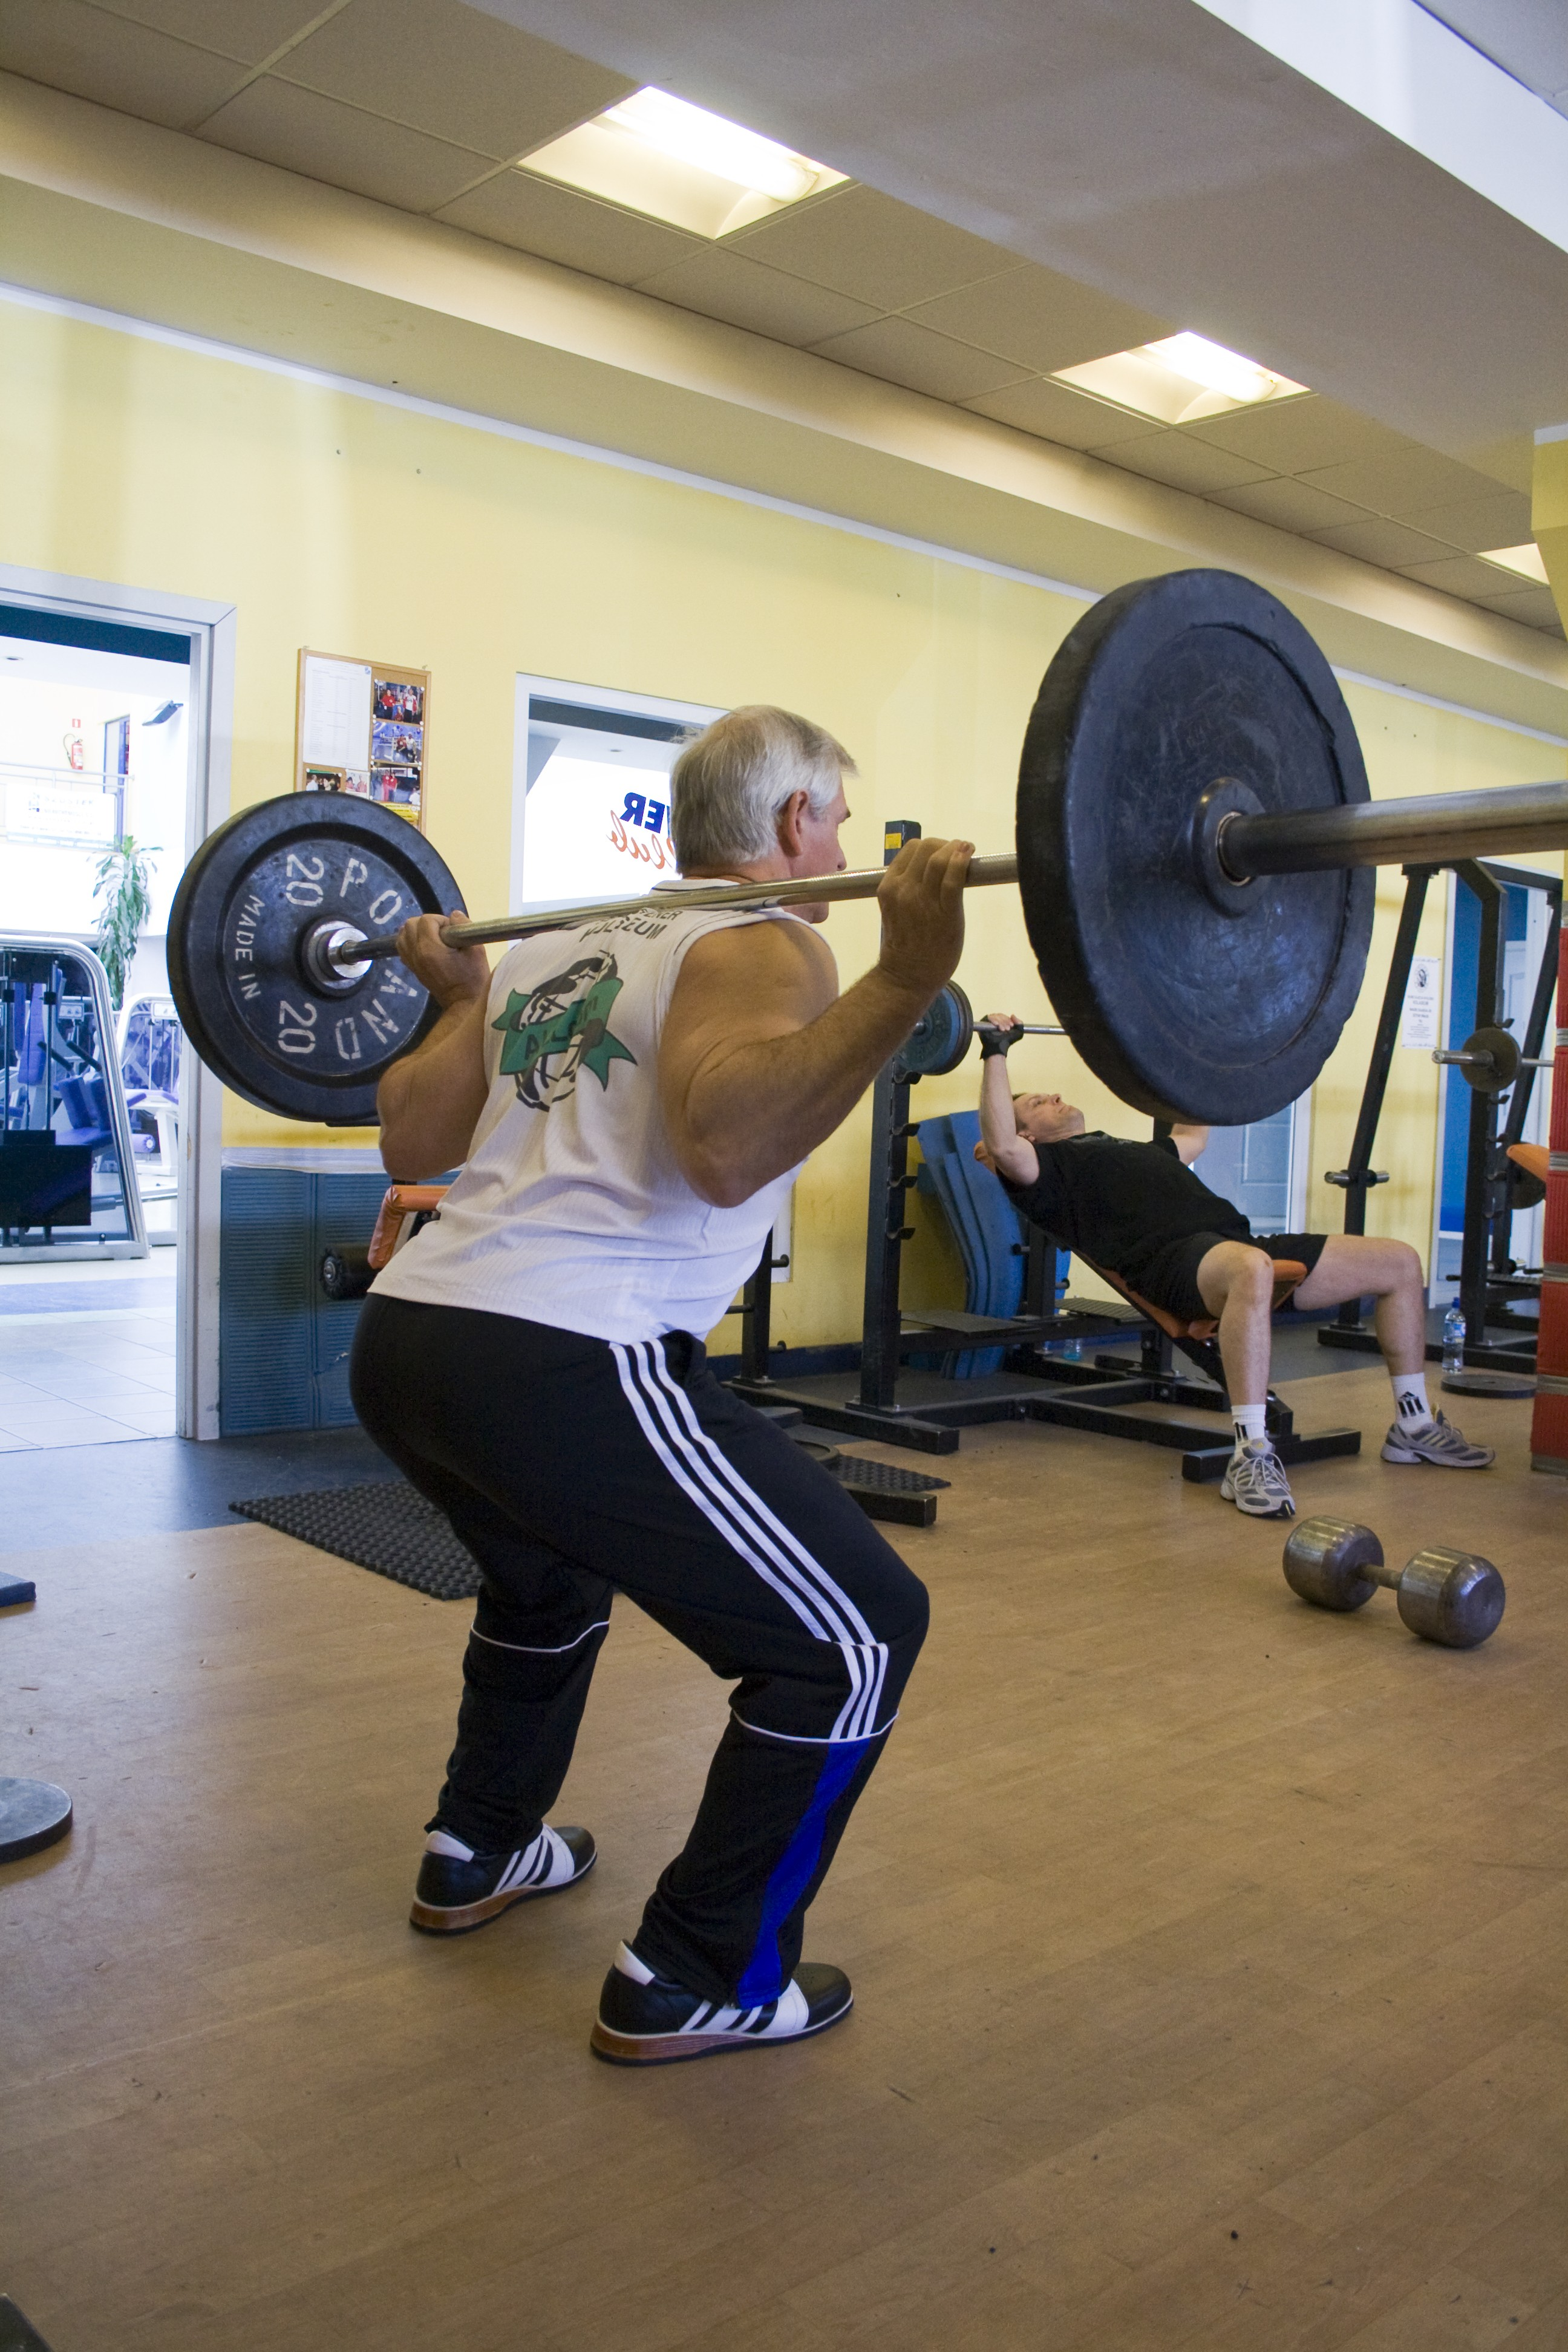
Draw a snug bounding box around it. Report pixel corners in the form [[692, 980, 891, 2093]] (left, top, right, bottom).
[[727, 188, 1018, 310]]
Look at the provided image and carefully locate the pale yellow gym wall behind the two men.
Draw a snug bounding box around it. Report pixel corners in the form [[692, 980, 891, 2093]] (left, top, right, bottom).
[[0, 308, 1563, 1345]]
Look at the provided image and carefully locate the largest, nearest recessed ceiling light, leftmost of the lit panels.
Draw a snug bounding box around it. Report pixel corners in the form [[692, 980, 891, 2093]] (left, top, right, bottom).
[[517, 90, 846, 238]]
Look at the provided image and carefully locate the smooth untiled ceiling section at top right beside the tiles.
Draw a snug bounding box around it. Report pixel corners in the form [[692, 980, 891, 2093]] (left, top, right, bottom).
[[465, 0, 1568, 472]]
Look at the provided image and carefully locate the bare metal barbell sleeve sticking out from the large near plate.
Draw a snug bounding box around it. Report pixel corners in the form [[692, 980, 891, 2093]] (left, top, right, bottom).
[[1215, 783, 1568, 882]]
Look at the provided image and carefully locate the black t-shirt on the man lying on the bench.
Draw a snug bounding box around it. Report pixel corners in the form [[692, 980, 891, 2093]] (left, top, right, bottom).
[[1001, 1131, 1253, 1289]]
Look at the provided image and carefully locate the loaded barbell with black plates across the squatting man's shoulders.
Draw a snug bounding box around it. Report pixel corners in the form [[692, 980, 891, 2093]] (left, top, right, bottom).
[[169, 572, 1568, 1126]]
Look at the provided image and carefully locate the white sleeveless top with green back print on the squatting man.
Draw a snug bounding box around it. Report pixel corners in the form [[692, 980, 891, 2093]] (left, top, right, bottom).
[[371, 901, 799, 1341]]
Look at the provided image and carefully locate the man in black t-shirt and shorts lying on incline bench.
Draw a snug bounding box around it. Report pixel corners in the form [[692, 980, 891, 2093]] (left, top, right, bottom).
[[976, 1014, 1493, 1520]]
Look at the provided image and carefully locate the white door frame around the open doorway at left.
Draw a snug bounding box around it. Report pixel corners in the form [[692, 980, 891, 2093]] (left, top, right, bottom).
[[0, 562, 237, 1437]]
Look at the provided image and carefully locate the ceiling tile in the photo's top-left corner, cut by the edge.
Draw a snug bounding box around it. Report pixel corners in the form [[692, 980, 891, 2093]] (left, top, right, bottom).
[[0, 0, 244, 129]]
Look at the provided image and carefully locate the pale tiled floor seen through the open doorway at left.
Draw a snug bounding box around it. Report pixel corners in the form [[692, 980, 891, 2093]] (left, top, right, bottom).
[[0, 1251, 174, 1454]]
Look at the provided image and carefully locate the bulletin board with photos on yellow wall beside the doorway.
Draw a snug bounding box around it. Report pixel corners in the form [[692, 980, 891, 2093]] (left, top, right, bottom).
[[294, 644, 430, 832]]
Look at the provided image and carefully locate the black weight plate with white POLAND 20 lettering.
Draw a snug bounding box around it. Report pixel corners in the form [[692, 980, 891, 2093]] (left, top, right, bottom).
[[169, 792, 461, 1126]]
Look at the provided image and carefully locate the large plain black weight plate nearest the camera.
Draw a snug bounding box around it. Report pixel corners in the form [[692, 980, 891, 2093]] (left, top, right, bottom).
[[1018, 572, 1375, 1126]]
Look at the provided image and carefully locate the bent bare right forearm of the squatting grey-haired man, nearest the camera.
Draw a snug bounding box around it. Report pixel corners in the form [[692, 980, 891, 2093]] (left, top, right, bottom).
[[684, 967, 926, 1209]]
